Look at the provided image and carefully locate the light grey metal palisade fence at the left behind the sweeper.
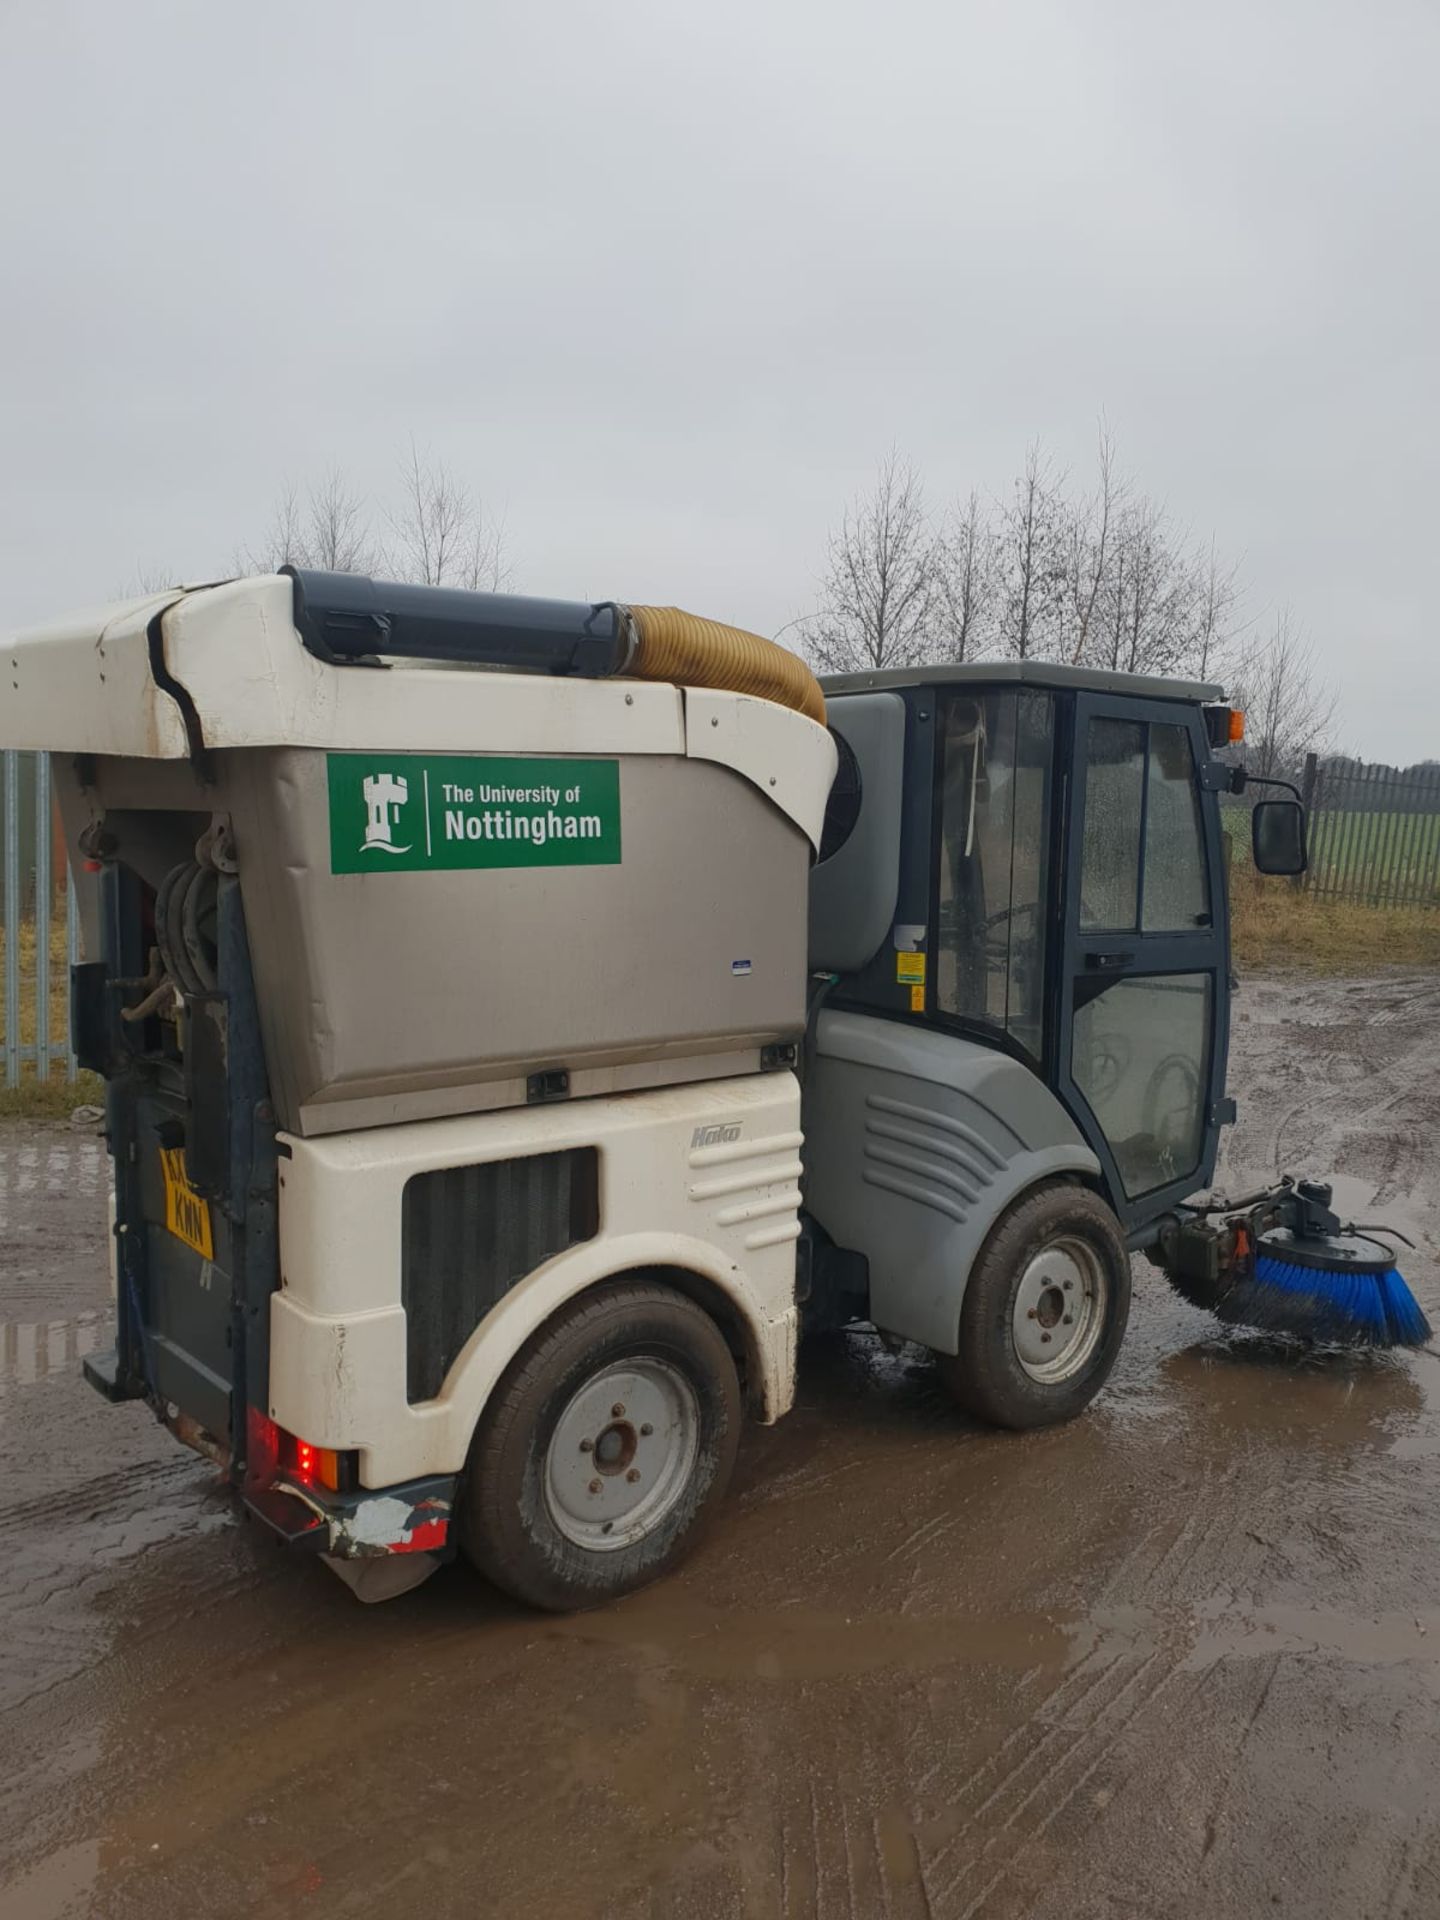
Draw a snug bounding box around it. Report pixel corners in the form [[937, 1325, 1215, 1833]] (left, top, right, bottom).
[[0, 747, 79, 1087]]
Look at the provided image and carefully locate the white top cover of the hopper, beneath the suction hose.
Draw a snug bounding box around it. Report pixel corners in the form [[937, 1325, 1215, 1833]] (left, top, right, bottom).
[[0, 574, 835, 847]]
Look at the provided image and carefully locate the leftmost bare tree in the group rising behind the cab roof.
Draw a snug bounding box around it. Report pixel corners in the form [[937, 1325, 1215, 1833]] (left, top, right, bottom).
[[806, 453, 941, 674]]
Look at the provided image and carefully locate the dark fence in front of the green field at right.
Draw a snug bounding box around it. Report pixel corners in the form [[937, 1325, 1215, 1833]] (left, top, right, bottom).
[[1302, 753, 1440, 906]]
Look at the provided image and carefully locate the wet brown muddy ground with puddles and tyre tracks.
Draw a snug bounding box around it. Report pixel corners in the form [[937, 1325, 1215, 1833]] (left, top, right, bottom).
[[0, 975, 1440, 1920]]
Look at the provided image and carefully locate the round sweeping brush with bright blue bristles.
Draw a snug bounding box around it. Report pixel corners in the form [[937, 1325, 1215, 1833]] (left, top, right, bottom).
[[1212, 1227, 1430, 1346]]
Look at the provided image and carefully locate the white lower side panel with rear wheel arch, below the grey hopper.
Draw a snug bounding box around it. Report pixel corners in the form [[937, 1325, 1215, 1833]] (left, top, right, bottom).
[[271, 1073, 801, 1486]]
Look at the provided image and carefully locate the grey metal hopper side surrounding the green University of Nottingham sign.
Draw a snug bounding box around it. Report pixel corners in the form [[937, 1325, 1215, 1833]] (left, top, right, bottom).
[[56, 747, 812, 1135]]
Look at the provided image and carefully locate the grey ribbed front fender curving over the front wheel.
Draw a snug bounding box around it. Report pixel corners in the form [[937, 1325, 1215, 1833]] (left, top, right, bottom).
[[804, 1010, 1100, 1354]]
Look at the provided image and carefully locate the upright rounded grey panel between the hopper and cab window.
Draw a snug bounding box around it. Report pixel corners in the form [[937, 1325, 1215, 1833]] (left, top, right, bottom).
[[810, 693, 904, 973]]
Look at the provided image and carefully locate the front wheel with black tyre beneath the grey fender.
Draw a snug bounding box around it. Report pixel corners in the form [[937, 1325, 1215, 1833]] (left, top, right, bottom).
[[935, 1183, 1131, 1428]]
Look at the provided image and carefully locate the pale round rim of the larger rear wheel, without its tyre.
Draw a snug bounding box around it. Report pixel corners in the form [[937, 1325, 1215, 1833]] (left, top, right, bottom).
[[545, 1357, 701, 1553]]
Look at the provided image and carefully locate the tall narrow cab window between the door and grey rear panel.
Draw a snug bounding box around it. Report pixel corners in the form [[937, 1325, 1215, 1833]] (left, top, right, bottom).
[[935, 689, 1054, 1060]]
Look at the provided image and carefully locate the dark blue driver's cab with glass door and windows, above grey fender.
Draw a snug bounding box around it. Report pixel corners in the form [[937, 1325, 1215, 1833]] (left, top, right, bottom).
[[812, 662, 1231, 1227]]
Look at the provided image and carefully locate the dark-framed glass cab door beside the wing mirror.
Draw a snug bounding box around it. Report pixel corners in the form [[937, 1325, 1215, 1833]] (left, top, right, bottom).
[[1056, 693, 1229, 1227]]
